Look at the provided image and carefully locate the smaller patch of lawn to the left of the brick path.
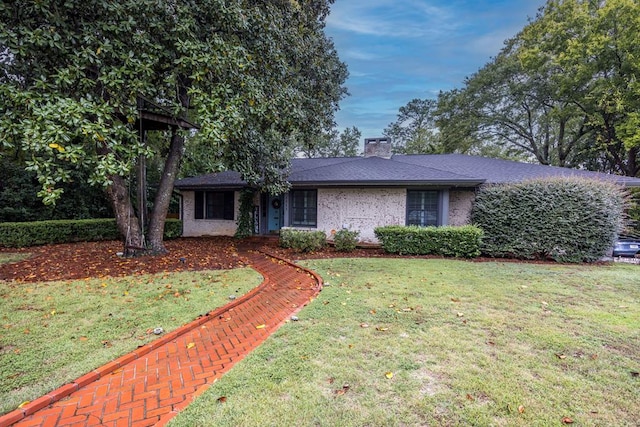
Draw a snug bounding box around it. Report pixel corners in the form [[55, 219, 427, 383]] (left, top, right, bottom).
[[0, 270, 262, 414]]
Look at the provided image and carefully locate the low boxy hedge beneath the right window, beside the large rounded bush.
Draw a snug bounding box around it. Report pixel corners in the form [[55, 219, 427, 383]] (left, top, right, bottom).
[[374, 225, 482, 258]]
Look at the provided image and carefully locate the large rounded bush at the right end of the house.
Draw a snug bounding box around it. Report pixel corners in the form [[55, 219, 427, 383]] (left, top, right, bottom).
[[471, 178, 627, 262]]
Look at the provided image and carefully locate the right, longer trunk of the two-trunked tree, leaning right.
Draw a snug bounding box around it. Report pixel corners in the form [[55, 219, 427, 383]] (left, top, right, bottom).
[[148, 130, 184, 254]]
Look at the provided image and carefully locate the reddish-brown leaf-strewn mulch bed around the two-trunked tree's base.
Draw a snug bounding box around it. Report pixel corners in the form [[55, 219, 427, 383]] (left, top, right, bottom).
[[0, 237, 245, 282]]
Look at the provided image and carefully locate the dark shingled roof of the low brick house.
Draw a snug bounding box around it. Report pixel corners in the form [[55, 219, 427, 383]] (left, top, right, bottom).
[[175, 154, 640, 190]]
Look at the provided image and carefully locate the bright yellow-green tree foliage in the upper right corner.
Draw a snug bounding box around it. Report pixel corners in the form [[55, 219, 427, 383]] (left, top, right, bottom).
[[518, 0, 640, 176]]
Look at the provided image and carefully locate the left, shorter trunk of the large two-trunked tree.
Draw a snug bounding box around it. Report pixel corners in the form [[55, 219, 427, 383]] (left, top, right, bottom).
[[107, 175, 145, 256]]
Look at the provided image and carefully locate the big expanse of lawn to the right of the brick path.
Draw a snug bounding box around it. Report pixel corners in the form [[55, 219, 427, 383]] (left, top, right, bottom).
[[171, 259, 640, 427]]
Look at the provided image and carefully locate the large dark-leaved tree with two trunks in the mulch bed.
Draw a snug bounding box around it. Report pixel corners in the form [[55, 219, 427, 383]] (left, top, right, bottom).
[[0, 0, 347, 252]]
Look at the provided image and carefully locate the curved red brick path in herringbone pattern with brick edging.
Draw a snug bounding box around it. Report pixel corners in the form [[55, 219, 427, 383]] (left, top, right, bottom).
[[0, 245, 322, 427]]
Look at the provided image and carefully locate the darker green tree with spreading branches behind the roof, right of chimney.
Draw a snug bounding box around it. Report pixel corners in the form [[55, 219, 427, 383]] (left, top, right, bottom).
[[438, 38, 589, 166]]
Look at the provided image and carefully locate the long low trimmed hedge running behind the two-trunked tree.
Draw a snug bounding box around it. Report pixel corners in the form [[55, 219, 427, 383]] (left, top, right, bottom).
[[0, 218, 182, 248]]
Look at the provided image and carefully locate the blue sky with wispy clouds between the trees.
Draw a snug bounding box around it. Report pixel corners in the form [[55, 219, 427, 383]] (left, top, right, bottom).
[[326, 0, 546, 139]]
